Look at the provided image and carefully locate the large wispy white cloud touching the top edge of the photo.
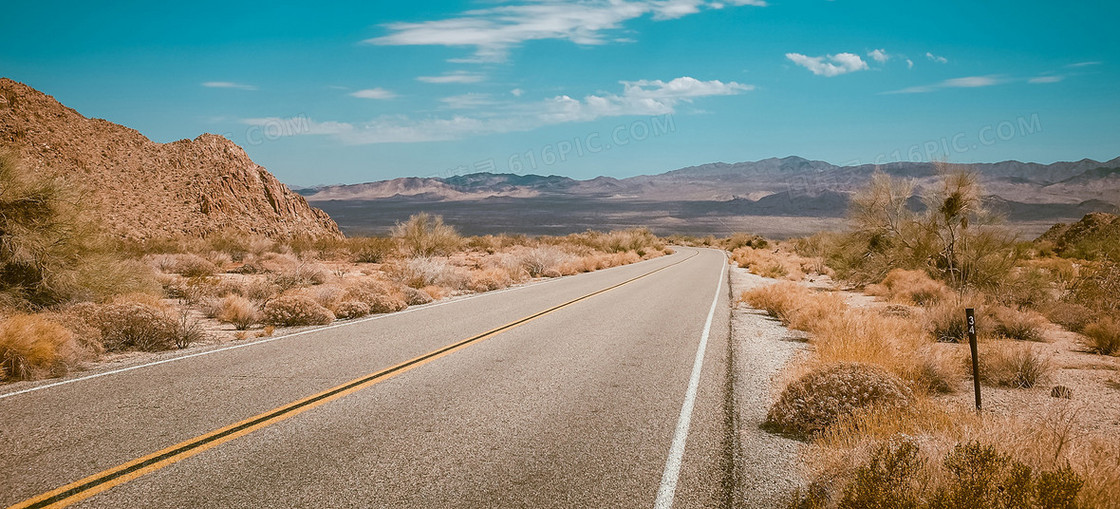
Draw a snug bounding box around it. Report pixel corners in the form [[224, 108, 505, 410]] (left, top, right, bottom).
[[364, 0, 766, 63]]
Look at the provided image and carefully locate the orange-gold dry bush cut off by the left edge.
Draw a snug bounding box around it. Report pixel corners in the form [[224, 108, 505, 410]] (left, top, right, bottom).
[[0, 314, 78, 381]]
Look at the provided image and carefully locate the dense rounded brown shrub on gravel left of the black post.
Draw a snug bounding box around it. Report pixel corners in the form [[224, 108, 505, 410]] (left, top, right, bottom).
[[766, 363, 913, 437]]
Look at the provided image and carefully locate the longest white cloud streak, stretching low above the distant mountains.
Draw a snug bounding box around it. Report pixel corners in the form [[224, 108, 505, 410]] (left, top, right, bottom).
[[242, 76, 754, 145]]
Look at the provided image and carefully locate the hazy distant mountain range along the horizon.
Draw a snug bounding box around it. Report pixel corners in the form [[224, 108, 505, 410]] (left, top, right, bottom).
[[298, 156, 1120, 237]]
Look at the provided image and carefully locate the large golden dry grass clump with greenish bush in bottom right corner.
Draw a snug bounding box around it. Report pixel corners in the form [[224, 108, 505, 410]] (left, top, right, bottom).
[[796, 399, 1106, 508]]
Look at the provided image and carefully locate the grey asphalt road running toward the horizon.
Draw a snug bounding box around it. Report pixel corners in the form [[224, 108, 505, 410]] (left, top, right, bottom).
[[0, 248, 735, 508]]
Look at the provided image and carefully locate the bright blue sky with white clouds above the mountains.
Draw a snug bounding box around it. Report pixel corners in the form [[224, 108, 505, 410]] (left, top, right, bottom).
[[0, 0, 1120, 185]]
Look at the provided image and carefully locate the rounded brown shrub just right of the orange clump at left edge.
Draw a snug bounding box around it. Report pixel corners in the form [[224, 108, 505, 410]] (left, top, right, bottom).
[[85, 296, 181, 351]]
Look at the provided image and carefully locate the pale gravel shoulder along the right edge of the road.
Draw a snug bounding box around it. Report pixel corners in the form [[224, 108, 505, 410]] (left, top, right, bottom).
[[730, 265, 808, 508]]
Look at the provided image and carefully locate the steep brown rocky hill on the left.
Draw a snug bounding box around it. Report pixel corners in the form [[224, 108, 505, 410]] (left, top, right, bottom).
[[0, 78, 340, 239]]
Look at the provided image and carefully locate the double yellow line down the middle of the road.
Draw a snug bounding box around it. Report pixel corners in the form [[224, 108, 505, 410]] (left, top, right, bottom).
[[9, 252, 699, 509]]
